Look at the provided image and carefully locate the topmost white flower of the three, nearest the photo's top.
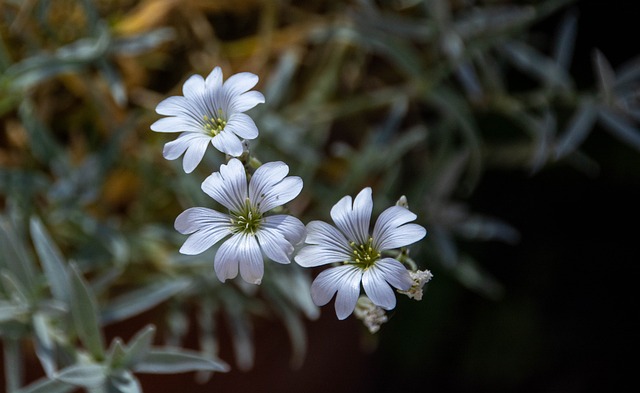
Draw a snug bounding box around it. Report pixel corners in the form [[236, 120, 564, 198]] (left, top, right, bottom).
[[151, 67, 264, 173]]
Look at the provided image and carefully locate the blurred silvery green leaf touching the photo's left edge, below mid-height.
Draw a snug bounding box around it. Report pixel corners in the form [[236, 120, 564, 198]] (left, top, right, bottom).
[[0, 216, 35, 293]]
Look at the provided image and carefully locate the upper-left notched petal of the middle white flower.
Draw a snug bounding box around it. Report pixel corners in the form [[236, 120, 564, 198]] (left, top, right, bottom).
[[202, 158, 247, 212]]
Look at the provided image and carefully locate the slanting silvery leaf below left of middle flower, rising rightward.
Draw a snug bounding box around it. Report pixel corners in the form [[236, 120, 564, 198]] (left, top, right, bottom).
[[101, 278, 190, 324]]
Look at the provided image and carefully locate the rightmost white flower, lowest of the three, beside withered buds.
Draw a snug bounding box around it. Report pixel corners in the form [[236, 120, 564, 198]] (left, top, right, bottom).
[[295, 187, 427, 319]]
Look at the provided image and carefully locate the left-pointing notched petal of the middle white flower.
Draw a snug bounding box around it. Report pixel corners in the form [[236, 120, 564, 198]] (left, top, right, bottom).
[[174, 207, 231, 255]]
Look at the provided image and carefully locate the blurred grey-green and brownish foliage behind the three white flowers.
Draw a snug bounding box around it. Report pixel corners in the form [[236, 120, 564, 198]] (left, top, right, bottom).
[[0, 0, 640, 393]]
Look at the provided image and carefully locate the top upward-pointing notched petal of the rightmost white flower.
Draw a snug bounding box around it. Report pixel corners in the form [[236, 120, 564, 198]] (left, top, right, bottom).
[[331, 187, 373, 244]]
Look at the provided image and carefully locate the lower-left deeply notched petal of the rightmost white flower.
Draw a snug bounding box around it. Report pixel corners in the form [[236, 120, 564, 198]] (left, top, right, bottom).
[[311, 265, 362, 320]]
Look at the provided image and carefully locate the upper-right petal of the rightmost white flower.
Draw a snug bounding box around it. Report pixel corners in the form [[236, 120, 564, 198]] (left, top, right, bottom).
[[373, 206, 427, 250]]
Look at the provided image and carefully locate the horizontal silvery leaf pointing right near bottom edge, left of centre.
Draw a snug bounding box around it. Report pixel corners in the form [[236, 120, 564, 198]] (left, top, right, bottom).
[[133, 348, 229, 374]]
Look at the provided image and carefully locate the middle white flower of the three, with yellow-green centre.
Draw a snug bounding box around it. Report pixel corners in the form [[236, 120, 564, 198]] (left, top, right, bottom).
[[175, 158, 305, 284]]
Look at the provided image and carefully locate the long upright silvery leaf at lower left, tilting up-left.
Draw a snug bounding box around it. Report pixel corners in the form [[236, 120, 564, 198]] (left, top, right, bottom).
[[30, 217, 70, 303]]
